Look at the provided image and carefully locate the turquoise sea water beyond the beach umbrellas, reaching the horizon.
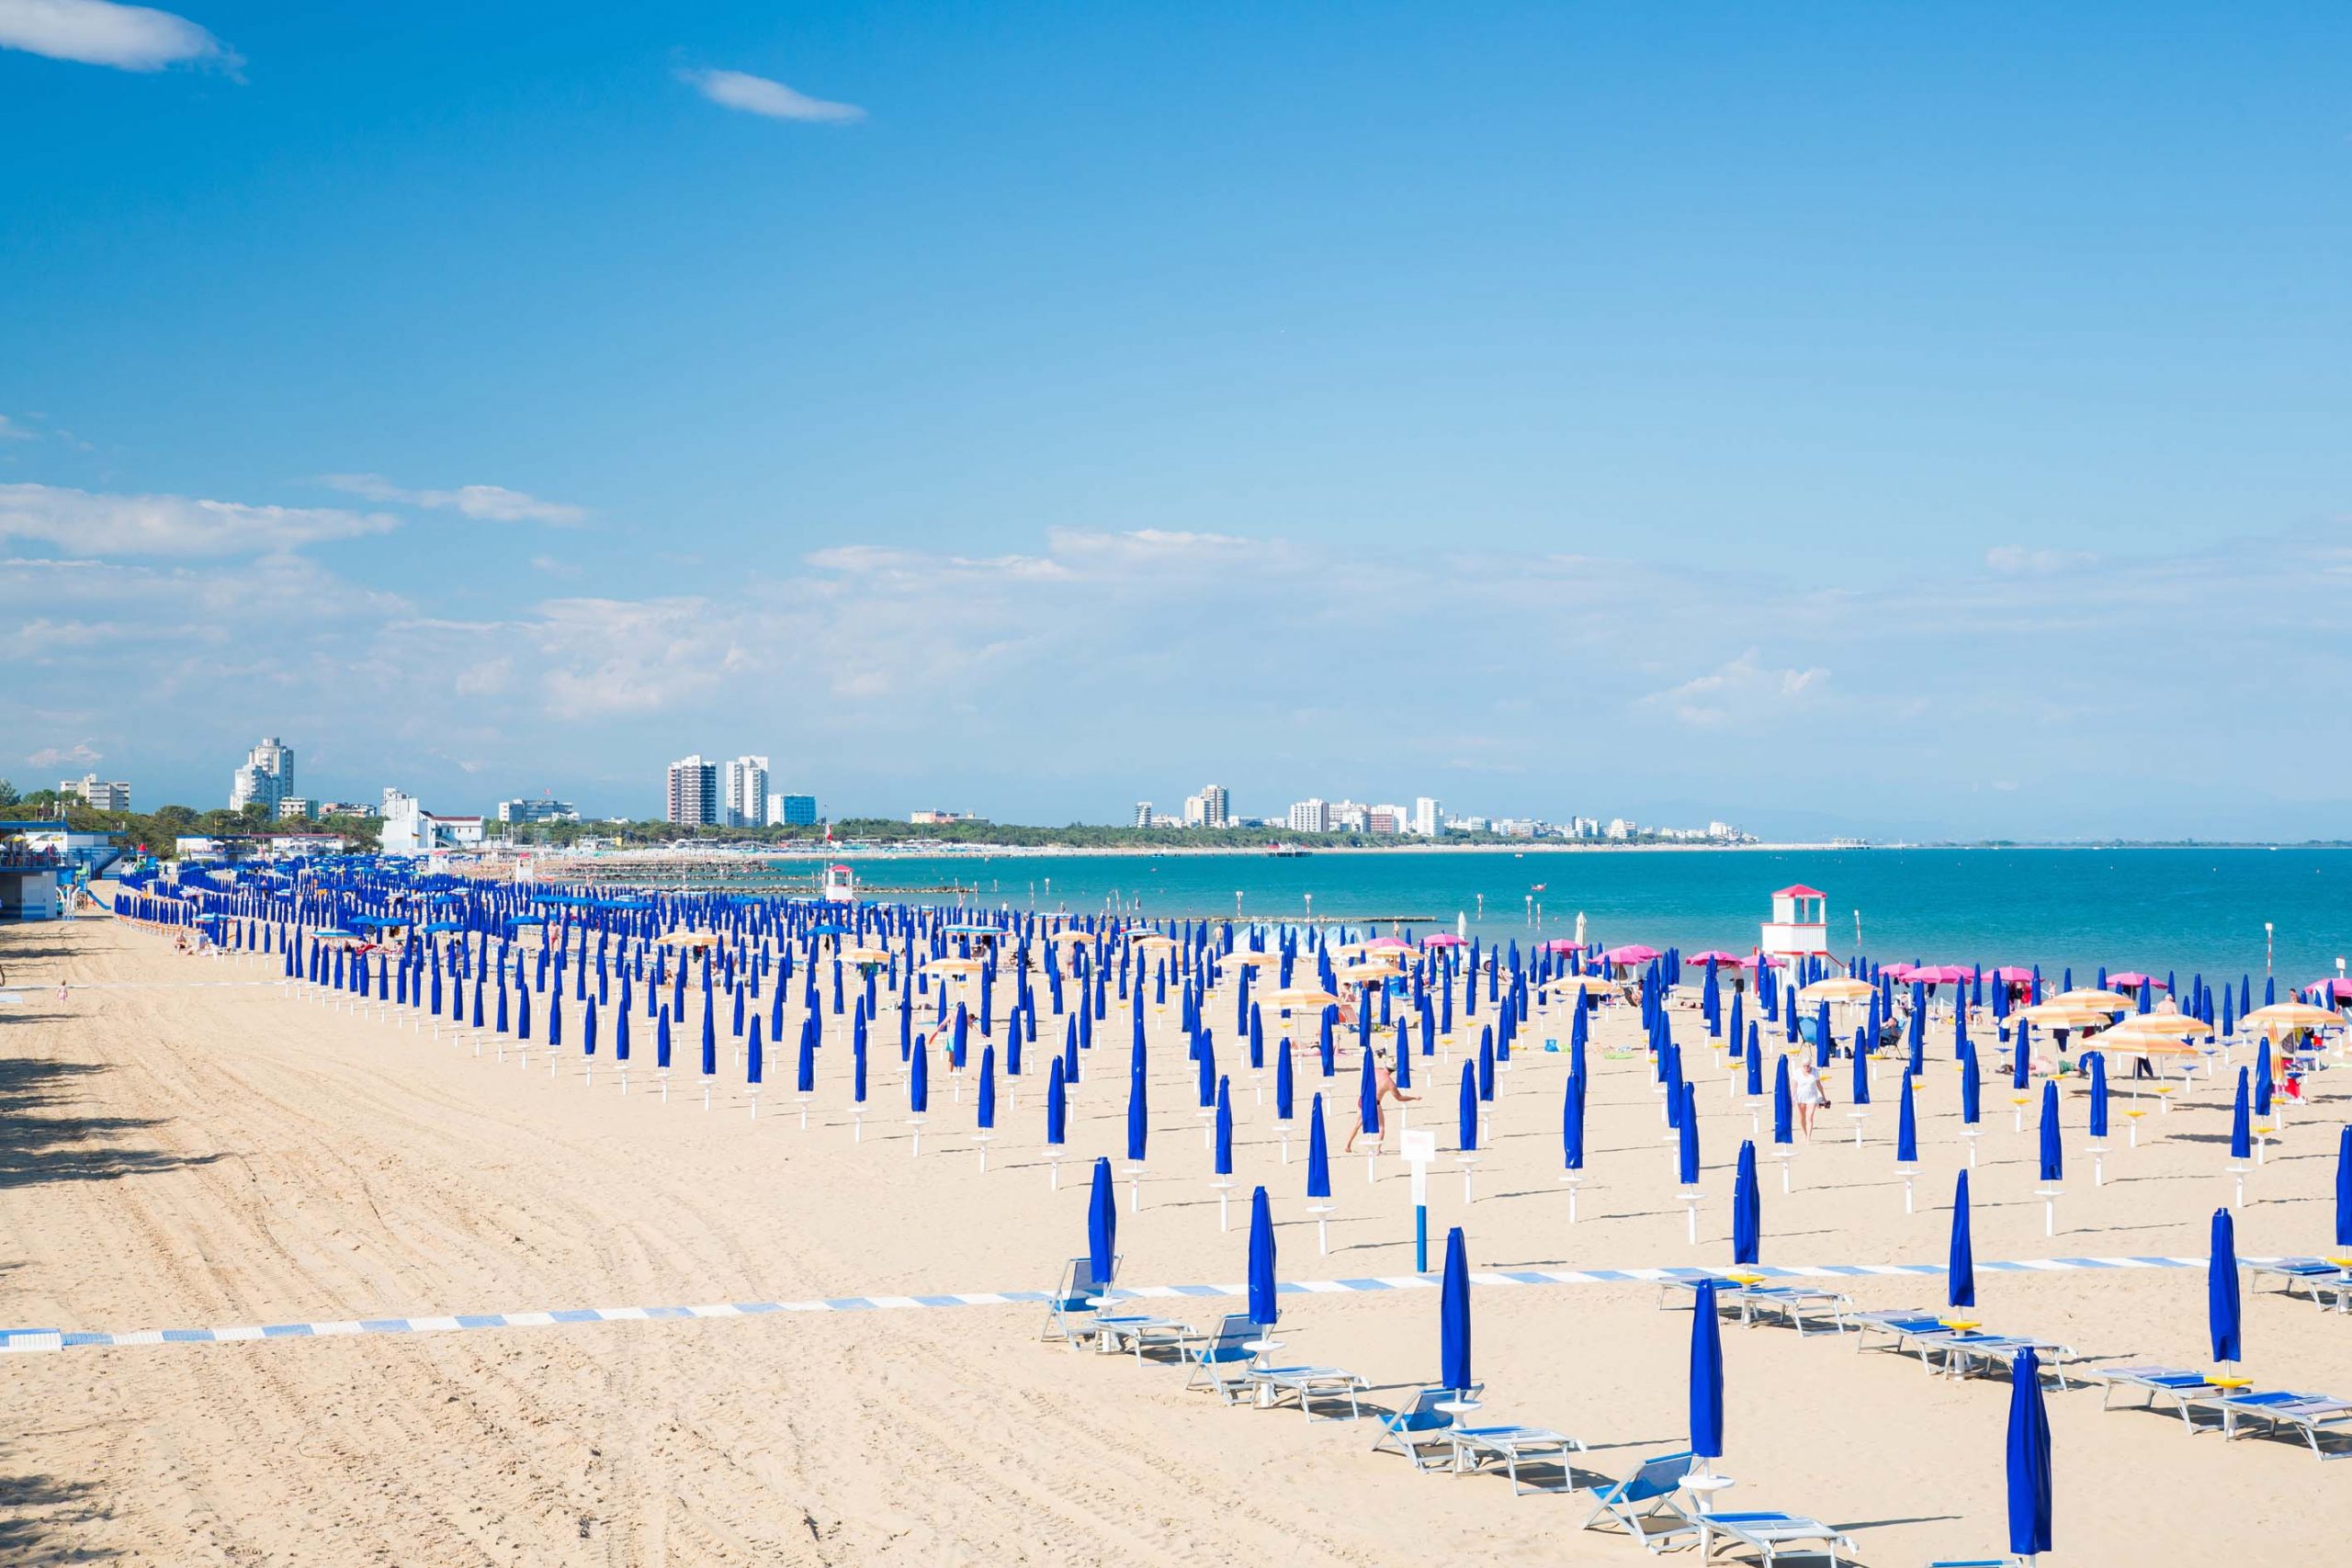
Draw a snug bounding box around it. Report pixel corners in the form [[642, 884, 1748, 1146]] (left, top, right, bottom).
[[813, 849, 2352, 985]]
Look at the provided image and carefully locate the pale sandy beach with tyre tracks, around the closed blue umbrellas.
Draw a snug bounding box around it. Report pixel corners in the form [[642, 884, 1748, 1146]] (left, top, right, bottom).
[[0, 919, 2352, 1568]]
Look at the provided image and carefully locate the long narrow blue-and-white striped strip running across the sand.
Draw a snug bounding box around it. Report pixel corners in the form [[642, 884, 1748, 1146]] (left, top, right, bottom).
[[0, 1258, 2206, 1352]]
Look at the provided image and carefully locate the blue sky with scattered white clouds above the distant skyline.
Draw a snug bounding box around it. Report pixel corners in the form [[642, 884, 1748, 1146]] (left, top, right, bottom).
[[0, 0, 2352, 840]]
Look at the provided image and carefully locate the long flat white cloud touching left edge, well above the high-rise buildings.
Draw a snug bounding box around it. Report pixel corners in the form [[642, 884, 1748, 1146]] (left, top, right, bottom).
[[0, 484, 395, 555]]
